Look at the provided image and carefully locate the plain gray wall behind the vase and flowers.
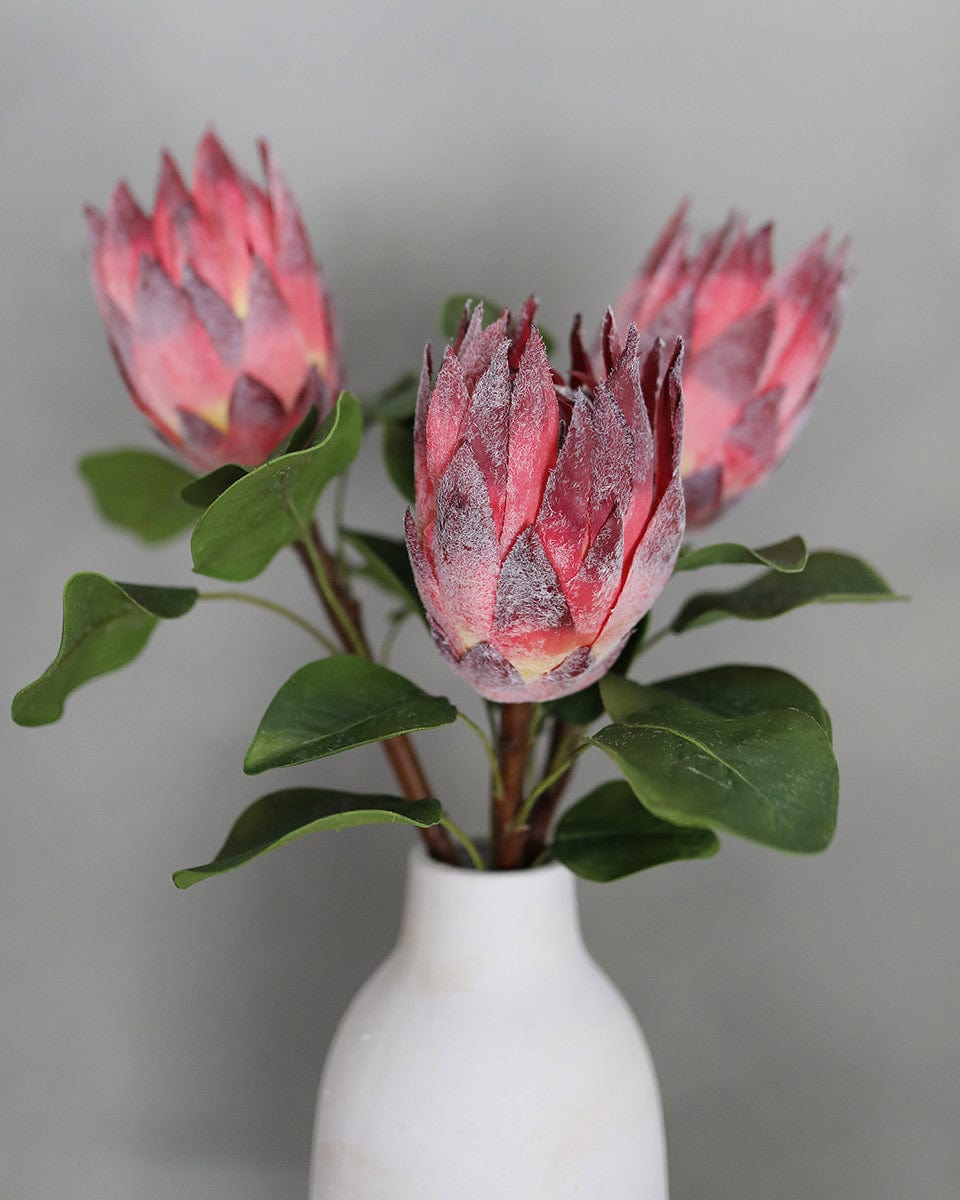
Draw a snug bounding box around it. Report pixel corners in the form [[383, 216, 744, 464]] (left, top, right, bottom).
[[0, 0, 960, 1200]]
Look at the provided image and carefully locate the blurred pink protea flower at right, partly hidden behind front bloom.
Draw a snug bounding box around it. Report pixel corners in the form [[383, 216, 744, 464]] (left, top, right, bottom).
[[616, 204, 847, 527]]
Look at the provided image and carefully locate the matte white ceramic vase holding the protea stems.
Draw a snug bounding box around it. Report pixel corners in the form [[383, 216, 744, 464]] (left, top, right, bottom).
[[310, 847, 667, 1200]]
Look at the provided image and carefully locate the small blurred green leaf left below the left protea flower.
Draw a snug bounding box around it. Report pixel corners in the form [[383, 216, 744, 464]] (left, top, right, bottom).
[[79, 450, 197, 542]]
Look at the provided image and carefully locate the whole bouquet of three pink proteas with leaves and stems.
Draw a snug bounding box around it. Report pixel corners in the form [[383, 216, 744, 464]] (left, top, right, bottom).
[[13, 134, 893, 887]]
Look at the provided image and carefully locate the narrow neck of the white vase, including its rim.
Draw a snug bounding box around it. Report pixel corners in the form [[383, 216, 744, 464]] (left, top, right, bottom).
[[397, 846, 587, 982]]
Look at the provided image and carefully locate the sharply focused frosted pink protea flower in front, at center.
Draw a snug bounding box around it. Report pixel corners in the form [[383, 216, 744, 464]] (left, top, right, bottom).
[[407, 300, 684, 703]]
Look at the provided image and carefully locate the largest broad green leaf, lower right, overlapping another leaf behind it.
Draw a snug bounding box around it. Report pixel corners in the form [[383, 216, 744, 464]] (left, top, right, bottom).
[[589, 682, 839, 853]]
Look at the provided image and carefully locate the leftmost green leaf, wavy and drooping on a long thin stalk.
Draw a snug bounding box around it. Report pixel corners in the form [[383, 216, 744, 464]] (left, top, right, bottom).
[[12, 572, 197, 725]]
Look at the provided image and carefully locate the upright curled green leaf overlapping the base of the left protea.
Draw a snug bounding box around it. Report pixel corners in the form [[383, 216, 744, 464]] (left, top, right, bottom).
[[191, 391, 361, 580]]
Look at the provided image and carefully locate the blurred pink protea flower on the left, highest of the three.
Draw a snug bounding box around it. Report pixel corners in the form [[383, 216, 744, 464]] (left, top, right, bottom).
[[86, 133, 341, 470]]
